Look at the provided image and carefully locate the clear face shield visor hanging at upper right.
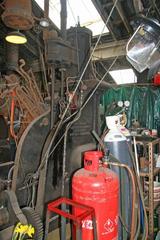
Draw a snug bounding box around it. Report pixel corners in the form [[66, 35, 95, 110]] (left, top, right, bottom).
[[126, 17, 160, 72]]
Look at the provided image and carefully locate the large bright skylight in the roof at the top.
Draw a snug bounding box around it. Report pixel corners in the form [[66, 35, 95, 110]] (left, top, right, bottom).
[[36, 0, 109, 36]]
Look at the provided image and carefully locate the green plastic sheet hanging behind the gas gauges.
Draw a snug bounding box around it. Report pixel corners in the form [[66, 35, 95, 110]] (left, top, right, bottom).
[[101, 86, 160, 129]]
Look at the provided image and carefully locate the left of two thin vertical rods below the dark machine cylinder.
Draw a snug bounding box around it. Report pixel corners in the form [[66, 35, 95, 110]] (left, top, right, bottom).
[[50, 66, 55, 129]]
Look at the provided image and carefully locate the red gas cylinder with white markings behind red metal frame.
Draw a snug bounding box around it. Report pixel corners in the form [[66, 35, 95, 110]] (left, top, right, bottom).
[[72, 151, 119, 240]]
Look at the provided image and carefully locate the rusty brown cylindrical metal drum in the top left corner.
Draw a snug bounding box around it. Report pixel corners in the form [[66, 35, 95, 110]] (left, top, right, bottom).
[[2, 0, 34, 30]]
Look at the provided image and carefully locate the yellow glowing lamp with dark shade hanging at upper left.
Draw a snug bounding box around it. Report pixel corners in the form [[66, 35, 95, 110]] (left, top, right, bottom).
[[5, 31, 27, 44]]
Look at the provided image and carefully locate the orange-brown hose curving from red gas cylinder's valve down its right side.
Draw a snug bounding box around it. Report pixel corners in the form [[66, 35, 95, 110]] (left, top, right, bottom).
[[105, 162, 136, 240]]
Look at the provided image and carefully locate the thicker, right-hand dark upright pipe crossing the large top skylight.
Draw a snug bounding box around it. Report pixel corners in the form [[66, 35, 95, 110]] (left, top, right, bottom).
[[61, 0, 67, 40]]
